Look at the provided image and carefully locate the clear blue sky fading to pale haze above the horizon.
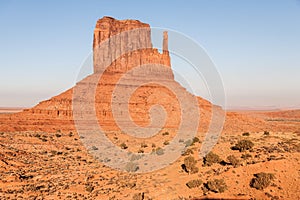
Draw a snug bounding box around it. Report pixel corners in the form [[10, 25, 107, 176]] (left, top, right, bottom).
[[0, 0, 300, 109]]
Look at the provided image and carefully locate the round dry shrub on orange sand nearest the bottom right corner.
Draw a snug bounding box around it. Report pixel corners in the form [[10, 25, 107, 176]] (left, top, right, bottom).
[[250, 172, 275, 190]]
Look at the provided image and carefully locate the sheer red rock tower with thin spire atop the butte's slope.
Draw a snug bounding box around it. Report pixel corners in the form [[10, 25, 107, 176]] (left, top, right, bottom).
[[93, 17, 170, 73]]
